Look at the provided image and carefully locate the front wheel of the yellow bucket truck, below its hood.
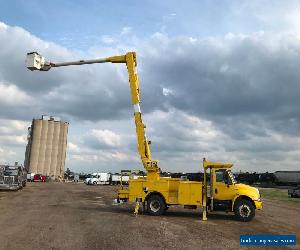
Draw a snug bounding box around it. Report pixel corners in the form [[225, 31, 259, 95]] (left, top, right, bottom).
[[234, 199, 255, 222]]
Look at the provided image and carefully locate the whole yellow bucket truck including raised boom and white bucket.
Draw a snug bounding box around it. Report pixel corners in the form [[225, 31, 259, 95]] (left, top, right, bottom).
[[26, 52, 262, 221]]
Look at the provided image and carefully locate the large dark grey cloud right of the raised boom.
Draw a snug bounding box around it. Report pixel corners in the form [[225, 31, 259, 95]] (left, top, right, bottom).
[[143, 33, 300, 133]]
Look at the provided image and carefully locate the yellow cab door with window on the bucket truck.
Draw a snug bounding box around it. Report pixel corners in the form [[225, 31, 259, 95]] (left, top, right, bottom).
[[212, 169, 235, 200]]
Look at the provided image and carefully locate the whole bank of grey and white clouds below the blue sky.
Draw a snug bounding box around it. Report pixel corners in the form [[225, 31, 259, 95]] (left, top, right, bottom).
[[0, 21, 300, 173]]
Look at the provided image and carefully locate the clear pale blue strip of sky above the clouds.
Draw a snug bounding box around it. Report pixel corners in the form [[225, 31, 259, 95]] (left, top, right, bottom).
[[0, 0, 296, 49]]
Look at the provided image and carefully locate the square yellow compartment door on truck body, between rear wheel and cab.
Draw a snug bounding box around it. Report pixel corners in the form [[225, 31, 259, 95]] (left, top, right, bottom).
[[178, 181, 202, 205]]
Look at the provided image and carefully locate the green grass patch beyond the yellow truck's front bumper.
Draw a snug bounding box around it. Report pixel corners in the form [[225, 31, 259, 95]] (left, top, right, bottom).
[[259, 188, 300, 203]]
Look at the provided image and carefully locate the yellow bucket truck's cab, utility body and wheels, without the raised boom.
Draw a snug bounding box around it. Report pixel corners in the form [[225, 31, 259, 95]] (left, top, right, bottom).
[[118, 159, 262, 221]]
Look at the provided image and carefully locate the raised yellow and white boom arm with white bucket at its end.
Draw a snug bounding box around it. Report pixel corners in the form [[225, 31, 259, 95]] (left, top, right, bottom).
[[26, 52, 160, 180]]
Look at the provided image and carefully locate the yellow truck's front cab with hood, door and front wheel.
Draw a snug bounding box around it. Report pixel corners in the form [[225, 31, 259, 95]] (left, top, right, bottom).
[[208, 165, 262, 221]]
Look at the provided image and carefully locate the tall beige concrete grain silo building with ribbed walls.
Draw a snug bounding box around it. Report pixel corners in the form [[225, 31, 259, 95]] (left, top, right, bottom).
[[24, 115, 69, 179]]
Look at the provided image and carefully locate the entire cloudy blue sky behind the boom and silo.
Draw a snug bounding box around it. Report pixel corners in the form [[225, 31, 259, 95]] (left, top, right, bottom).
[[0, 0, 300, 173]]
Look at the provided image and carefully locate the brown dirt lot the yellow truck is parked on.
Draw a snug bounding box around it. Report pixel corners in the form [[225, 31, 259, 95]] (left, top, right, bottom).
[[0, 183, 300, 249]]
